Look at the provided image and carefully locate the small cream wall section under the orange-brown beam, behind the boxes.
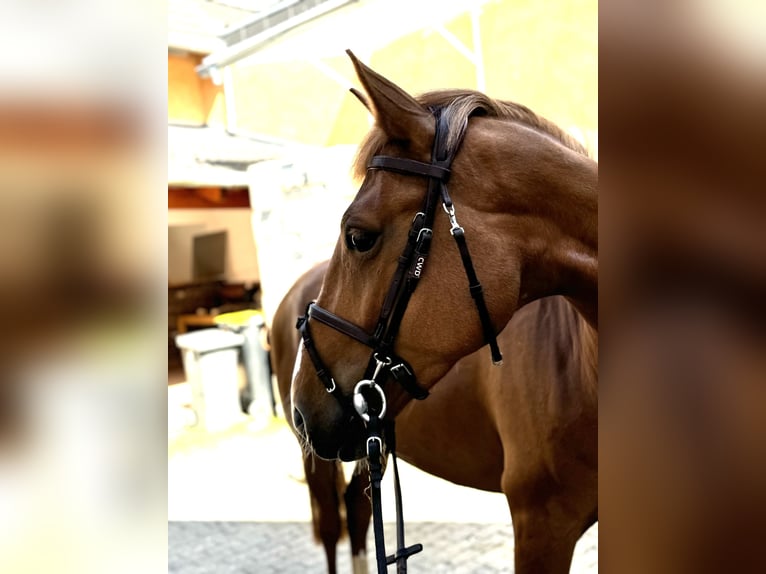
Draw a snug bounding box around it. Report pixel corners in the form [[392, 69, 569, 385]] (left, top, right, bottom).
[[168, 208, 260, 282]]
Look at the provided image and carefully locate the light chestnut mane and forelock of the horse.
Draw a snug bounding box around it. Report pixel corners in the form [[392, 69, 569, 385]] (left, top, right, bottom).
[[353, 89, 588, 179]]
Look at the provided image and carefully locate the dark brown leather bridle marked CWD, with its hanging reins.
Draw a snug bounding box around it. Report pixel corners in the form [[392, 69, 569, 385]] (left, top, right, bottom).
[[296, 109, 502, 573]]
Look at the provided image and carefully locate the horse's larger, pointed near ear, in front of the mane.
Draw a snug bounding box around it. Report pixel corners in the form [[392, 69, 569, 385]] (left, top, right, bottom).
[[346, 50, 434, 145]]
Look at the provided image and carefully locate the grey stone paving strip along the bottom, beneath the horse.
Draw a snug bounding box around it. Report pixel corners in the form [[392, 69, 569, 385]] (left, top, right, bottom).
[[168, 522, 598, 574]]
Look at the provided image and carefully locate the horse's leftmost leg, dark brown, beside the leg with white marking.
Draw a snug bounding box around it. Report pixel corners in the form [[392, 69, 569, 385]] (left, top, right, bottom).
[[303, 457, 345, 574]]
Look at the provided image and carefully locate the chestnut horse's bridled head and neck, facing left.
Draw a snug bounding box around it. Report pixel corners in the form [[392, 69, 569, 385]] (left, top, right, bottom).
[[292, 53, 598, 460]]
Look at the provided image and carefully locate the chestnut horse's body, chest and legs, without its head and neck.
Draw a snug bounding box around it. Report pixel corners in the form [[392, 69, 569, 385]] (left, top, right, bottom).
[[271, 262, 598, 574]]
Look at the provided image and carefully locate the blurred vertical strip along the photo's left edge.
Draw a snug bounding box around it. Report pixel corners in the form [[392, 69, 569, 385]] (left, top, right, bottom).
[[0, 0, 167, 573]]
